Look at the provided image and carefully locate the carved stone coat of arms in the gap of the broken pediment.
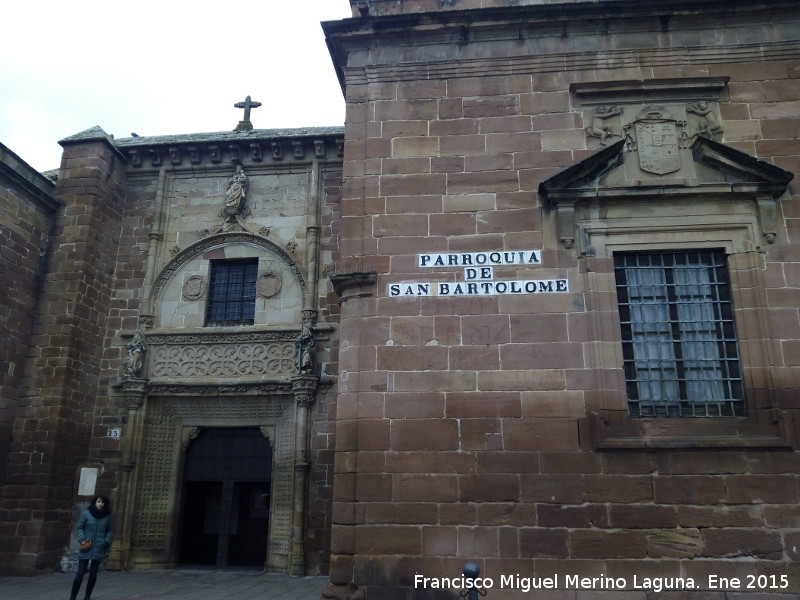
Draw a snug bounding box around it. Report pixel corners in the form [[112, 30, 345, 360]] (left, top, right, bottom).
[[624, 104, 686, 175]]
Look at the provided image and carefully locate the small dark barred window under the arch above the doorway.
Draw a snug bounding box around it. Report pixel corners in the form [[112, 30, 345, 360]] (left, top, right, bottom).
[[206, 258, 258, 326]]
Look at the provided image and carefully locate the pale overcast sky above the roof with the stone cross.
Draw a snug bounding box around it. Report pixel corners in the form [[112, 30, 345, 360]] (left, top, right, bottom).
[[0, 0, 351, 171]]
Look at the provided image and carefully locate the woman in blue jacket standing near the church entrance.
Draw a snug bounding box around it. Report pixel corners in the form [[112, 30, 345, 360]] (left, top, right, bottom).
[[69, 496, 114, 600]]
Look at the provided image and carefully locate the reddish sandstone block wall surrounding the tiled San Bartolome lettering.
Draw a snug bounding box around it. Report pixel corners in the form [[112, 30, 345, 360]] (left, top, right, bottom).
[[328, 2, 800, 599]]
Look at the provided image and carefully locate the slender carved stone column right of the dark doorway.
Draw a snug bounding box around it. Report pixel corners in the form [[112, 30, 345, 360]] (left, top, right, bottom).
[[288, 375, 319, 576]]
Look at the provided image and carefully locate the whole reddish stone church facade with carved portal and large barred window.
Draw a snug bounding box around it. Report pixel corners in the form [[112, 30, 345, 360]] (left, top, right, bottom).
[[0, 0, 800, 600]]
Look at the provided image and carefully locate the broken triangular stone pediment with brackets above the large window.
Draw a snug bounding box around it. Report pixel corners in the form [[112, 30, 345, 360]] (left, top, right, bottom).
[[539, 136, 794, 248]]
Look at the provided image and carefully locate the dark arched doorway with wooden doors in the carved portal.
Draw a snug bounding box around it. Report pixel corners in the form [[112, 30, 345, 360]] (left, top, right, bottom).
[[180, 427, 272, 566]]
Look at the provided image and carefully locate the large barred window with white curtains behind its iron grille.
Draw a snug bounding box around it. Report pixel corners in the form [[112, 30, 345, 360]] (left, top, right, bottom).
[[614, 250, 746, 417]]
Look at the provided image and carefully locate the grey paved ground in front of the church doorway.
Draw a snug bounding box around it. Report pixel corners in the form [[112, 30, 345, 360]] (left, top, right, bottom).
[[0, 568, 328, 600]]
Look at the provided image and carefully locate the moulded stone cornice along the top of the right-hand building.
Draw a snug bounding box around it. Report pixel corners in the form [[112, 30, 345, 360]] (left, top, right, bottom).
[[323, 0, 800, 88]]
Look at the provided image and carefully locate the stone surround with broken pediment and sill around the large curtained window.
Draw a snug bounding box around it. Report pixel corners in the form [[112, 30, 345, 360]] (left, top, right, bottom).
[[539, 96, 796, 450]]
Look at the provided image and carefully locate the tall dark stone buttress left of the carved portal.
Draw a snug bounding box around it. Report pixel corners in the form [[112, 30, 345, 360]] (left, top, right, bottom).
[[0, 136, 125, 575]]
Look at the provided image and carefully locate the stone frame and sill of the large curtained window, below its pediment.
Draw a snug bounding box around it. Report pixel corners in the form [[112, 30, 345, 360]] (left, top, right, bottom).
[[575, 207, 792, 449]]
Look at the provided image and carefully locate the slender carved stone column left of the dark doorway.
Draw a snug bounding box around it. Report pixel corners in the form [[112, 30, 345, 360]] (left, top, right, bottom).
[[108, 378, 147, 570]]
